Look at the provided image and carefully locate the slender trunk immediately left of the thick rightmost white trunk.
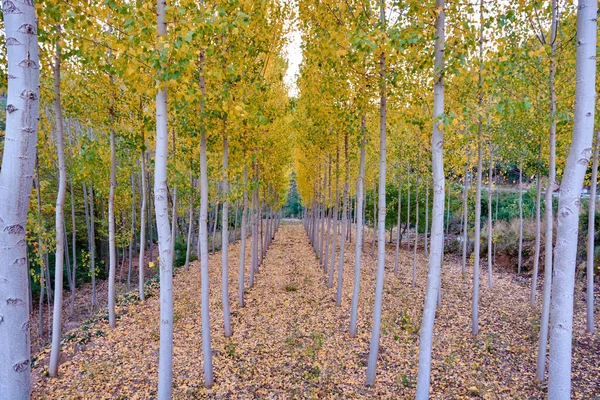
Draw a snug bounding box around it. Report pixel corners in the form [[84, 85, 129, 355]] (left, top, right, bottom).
[[536, 0, 564, 381]]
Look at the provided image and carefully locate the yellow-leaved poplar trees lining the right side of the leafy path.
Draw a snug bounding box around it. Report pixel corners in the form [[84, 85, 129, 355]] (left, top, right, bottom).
[[296, 1, 597, 398]]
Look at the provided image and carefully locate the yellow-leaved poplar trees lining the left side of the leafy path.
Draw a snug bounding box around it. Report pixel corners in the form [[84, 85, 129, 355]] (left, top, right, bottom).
[[0, 1, 292, 399]]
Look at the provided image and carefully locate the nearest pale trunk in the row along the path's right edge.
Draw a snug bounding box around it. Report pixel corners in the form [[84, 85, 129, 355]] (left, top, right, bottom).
[[415, 0, 446, 394]]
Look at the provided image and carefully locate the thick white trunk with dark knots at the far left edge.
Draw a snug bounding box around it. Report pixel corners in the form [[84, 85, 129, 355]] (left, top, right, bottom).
[[0, 1, 40, 394]]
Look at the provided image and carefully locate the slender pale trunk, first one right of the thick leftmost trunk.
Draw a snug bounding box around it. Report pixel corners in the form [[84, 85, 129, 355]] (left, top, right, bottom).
[[49, 32, 67, 378]]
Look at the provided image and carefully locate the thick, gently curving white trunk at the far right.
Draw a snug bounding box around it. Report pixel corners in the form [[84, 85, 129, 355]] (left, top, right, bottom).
[[548, 0, 598, 400]]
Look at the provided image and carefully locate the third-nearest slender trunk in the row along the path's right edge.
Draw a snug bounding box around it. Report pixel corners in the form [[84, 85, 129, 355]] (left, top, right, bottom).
[[350, 115, 367, 338]]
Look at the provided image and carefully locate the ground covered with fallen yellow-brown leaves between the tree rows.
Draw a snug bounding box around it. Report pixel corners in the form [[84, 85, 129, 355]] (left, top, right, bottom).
[[32, 224, 600, 399]]
